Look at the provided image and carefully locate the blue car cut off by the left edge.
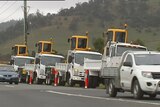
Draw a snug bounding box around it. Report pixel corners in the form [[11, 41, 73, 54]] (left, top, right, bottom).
[[0, 65, 19, 84]]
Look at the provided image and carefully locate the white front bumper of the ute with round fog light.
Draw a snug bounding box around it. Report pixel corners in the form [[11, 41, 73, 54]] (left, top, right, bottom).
[[140, 79, 160, 94]]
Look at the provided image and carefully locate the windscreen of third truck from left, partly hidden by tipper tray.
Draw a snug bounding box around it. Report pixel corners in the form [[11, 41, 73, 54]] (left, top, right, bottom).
[[75, 53, 101, 65]]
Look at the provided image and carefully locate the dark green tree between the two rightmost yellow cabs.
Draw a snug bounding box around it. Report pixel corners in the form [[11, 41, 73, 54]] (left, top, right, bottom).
[[93, 38, 104, 53]]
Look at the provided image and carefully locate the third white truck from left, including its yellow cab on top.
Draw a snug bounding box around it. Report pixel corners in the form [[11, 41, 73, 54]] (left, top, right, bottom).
[[56, 35, 102, 86]]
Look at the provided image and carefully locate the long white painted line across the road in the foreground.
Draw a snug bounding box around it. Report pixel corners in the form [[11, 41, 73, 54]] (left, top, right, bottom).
[[46, 91, 160, 106]]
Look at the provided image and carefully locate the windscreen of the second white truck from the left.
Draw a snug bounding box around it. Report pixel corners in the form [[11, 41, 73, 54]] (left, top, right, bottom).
[[41, 56, 63, 66]]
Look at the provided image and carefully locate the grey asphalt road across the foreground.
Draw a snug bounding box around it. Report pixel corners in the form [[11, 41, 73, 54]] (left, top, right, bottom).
[[0, 83, 160, 107]]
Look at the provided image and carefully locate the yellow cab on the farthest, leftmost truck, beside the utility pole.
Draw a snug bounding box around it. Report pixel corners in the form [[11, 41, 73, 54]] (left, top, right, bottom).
[[12, 45, 28, 56]]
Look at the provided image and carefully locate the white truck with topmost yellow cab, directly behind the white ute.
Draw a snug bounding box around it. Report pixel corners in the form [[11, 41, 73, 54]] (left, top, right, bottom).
[[84, 25, 147, 88]]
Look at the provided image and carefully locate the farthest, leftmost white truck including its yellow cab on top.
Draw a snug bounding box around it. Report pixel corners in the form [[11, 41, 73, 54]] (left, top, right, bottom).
[[10, 44, 34, 82]]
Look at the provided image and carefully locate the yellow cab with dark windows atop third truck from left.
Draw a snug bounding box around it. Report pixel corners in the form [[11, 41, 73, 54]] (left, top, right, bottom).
[[68, 35, 88, 50]]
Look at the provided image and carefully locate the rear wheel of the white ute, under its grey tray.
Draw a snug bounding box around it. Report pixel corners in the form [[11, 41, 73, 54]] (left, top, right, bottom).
[[108, 81, 117, 97]]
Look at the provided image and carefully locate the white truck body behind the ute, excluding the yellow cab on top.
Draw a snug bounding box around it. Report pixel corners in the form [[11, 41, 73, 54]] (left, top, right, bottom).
[[84, 42, 147, 88]]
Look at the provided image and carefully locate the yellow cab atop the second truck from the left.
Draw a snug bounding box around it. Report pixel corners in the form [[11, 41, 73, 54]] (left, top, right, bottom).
[[36, 41, 52, 54]]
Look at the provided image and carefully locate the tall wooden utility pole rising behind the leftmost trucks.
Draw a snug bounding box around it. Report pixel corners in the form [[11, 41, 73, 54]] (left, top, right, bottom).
[[24, 0, 28, 45]]
